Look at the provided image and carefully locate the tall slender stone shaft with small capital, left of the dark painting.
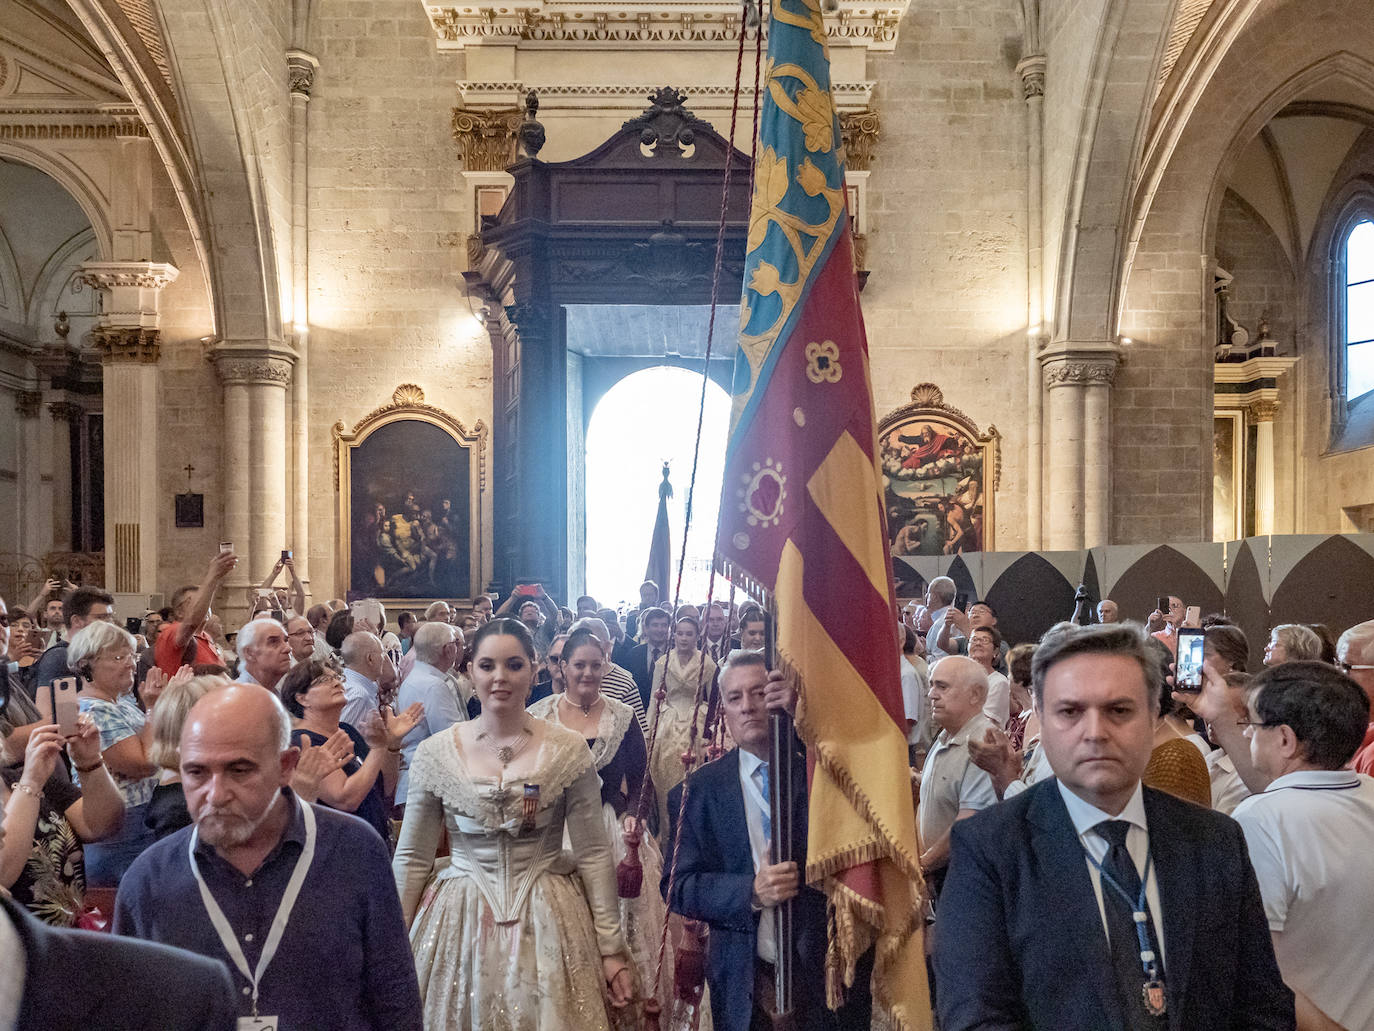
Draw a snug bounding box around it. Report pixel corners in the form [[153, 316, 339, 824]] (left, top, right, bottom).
[[286, 49, 320, 590]]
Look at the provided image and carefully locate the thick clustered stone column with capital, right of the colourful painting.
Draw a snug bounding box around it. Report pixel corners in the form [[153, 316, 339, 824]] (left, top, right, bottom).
[[1039, 341, 1121, 551]]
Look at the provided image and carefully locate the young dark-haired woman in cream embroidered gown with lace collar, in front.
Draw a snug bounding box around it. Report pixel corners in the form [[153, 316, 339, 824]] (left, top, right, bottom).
[[393, 619, 635, 1031]]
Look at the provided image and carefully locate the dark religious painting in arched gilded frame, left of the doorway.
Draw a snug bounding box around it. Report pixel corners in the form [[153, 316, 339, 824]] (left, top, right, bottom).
[[335, 385, 485, 601]]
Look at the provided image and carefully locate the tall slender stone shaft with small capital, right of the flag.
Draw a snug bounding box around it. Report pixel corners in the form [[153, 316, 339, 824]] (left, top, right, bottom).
[[1017, 54, 1048, 550]]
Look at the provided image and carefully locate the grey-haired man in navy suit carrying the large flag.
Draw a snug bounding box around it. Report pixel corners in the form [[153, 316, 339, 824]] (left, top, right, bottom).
[[662, 652, 872, 1031]]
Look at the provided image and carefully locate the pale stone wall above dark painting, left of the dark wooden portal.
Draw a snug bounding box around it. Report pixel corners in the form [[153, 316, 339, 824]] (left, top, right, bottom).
[[306, 0, 492, 598]]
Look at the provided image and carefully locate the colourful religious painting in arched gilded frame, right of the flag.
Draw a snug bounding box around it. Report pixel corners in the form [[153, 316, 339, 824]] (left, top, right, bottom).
[[878, 384, 1000, 555]]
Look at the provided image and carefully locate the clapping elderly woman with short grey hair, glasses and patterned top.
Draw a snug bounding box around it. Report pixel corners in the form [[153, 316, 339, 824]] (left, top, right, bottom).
[[67, 620, 177, 888]]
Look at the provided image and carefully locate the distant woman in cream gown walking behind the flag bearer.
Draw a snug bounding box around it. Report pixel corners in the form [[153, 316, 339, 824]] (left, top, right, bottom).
[[649, 616, 716, 851]]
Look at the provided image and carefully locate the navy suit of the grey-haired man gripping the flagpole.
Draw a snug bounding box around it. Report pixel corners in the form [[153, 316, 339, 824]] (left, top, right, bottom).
[[662, 748, 833, 1031]]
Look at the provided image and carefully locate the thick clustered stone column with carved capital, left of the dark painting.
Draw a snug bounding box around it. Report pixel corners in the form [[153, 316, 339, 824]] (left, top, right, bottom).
[[214, 349, 291, 602]]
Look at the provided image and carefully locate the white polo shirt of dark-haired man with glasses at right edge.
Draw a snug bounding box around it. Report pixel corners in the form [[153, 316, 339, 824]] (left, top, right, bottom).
[[1231, 770, 1374, 1028]]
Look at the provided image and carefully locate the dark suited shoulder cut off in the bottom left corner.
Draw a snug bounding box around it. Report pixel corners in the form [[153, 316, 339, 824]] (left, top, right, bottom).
[[0, 896, 238, 1031]]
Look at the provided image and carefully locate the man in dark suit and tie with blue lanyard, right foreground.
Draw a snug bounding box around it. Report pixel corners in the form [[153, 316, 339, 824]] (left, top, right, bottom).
[[934, 624, 1296, 1031]]
